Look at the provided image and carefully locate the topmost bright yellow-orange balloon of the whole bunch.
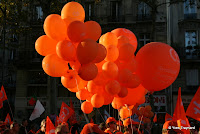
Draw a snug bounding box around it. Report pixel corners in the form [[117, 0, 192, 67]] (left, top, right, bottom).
[[61, 1, 85, 22]]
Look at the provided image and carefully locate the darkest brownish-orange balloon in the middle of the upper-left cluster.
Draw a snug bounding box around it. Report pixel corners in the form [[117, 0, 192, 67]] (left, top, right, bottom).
[[76, 39, 98, 64]]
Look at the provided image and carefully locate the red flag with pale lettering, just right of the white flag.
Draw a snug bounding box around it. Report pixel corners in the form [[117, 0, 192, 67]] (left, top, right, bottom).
[[59, 102, 74, 123]]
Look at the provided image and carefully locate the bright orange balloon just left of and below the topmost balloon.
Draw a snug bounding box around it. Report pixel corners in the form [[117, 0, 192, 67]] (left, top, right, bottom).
[[43, 14, 67, 41]]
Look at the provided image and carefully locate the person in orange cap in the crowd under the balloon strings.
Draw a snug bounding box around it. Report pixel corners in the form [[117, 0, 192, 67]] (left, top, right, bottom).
[[104, 117, 117, 134]]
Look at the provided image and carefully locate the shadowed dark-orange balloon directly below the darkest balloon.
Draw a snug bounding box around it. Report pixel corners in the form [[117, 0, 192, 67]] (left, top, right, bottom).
[[78, 63, 98, 81]]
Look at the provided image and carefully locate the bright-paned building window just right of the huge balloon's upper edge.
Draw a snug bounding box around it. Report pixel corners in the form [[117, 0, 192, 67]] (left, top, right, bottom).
[[185, 31, 197, 54]]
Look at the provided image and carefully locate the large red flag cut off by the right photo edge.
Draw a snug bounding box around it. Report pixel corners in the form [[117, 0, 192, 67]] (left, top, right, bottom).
[[186, 87, 200, 121]]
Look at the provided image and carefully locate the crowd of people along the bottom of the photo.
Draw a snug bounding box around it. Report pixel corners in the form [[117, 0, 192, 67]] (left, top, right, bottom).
[[0, 117, 200, 134]]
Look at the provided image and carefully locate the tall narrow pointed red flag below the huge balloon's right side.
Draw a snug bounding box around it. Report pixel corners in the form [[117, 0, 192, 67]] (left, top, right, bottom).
[[172, 88, 190, 134]]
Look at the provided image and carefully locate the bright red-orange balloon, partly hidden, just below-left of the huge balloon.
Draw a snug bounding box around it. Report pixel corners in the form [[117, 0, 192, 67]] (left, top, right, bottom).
[[114, 85, 145, 106]]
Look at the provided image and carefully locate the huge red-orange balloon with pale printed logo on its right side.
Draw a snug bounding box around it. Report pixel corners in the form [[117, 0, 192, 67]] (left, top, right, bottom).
[[136, 42, 180, 91]]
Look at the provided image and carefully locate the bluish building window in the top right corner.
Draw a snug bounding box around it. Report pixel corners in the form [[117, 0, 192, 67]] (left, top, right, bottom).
[[184, 0, 197, 19]]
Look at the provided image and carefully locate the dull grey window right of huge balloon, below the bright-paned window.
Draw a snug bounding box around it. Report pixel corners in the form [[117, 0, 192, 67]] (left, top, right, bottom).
[[186, 69, 199, 86]]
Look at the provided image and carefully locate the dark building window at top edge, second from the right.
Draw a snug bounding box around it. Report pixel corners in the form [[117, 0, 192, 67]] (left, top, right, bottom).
[[138, 2, 151, 20]]
